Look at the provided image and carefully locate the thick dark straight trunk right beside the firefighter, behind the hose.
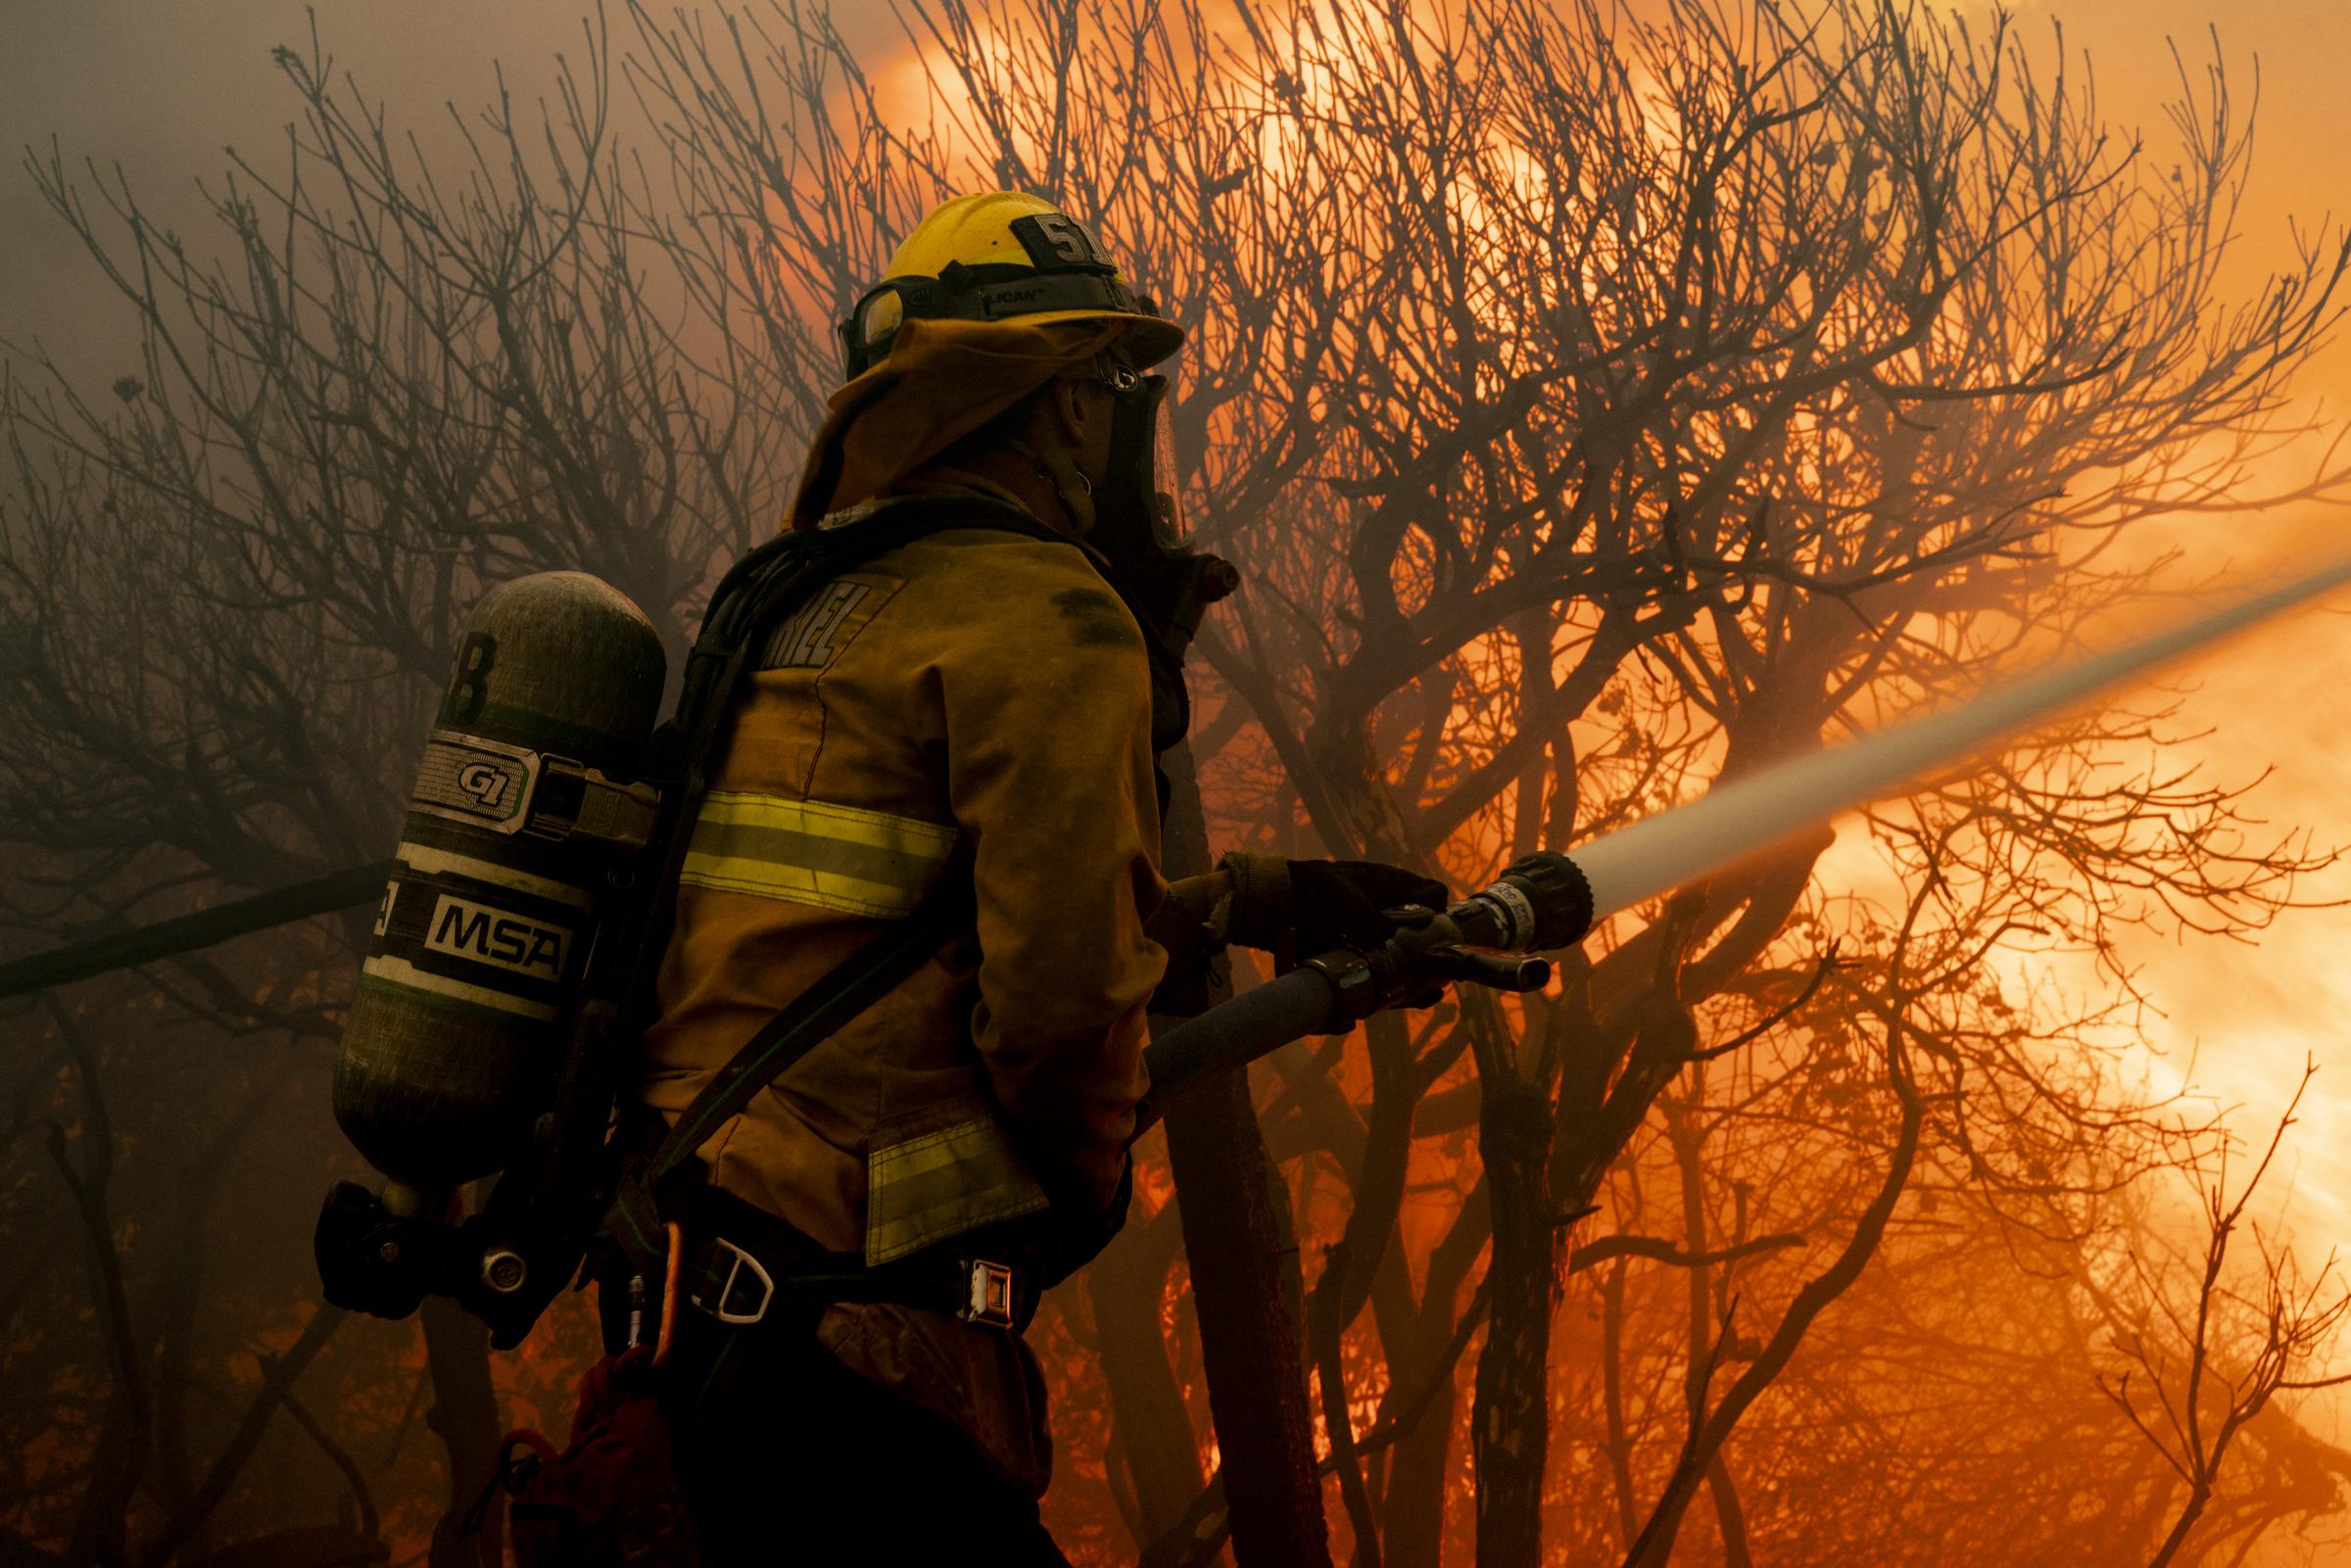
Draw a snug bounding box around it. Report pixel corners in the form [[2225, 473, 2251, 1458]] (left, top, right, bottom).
[[1164, 747, 1330, 1568]]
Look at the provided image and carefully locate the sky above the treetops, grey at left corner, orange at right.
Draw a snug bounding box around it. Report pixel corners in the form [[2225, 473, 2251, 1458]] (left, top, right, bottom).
[[0, 0, 2351, 381]]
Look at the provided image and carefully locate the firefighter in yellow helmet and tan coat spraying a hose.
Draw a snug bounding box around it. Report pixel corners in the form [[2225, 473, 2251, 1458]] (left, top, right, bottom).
[[635, 190, 1444, 1563]]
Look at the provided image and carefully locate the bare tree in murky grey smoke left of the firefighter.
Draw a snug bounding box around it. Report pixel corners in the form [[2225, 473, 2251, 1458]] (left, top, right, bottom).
[[0, 12, 774, 1563]]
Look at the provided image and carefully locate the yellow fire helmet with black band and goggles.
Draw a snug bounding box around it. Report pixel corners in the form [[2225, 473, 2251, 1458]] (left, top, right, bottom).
[[840, 190, 1182, 381]]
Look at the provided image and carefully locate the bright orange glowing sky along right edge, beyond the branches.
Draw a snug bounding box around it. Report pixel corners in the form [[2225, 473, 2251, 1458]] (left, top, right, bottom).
[[1955, 0, 2351, 1222]]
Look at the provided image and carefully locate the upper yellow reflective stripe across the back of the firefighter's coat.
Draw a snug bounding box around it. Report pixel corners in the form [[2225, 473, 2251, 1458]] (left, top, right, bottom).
[[680, 790, 957, 920]]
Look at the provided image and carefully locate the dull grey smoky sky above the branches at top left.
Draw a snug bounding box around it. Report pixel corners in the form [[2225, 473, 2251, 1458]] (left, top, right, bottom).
[[0, 0, 905, 378]]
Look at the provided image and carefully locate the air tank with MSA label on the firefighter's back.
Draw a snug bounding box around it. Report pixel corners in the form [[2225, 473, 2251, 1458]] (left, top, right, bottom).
[[334, 571, 665, 1190]]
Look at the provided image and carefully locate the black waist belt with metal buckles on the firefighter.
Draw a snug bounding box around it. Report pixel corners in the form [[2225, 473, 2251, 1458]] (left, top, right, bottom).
[[677, 1187, 1034, 1331]]
